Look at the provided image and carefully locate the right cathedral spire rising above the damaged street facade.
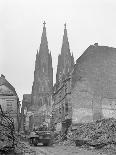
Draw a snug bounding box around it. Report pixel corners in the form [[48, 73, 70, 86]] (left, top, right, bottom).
[[56, 24, 74, 82]]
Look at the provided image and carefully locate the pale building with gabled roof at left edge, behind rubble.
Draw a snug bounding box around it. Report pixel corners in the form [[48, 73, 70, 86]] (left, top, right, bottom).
[[0, 75, 20, 131]]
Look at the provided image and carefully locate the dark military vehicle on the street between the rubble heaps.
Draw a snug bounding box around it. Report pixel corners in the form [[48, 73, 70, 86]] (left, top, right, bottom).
[[29, 125, 53, 146]]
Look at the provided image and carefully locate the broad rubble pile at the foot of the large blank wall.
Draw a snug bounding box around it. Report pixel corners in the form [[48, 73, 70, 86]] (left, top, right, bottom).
[[72, 118, 116, 148]]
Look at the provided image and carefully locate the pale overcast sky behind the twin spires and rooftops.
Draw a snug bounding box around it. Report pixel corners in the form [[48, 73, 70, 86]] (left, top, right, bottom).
[[0, 0, 116, 101]]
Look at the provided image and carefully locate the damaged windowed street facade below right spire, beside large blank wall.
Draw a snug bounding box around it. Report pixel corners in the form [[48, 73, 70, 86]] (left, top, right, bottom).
[[52, 76, 72, 133]]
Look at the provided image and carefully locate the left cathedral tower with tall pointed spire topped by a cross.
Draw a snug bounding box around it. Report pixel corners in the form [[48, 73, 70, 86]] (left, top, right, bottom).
[[32, 22, 53, 107]]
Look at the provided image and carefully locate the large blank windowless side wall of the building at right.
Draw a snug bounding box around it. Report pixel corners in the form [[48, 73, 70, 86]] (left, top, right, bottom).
[[71, 44, 116, 123]]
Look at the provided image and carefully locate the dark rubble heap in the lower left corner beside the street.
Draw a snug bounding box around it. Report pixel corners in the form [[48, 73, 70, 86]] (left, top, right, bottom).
[[0, 106, 36, 155]]
